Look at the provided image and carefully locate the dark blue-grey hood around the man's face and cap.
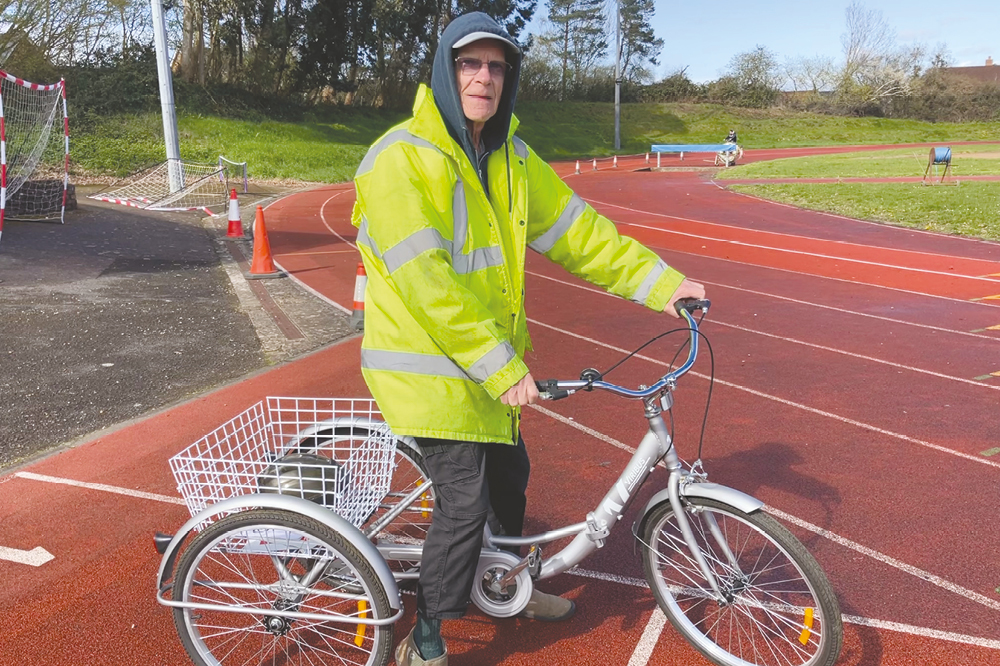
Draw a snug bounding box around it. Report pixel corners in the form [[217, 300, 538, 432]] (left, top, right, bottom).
[[431, 12, 521, 171]]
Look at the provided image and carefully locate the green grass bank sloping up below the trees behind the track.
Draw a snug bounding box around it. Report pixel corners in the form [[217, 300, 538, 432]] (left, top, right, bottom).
[[70, 100, 1000, 182]]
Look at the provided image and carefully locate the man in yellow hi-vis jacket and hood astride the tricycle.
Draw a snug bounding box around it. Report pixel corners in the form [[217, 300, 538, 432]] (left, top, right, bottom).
[[353, 12, 705, 666]]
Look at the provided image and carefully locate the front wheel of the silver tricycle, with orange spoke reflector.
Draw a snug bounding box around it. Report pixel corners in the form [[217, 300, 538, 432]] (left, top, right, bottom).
[[641, 497, 844, 666]]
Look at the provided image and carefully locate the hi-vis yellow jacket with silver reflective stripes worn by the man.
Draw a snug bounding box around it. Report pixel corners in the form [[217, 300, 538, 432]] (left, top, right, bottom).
[[352, 86, 683, 444]]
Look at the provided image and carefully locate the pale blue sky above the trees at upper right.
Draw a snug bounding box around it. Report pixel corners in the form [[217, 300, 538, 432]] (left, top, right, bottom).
[[528, 0, 1000, 83]]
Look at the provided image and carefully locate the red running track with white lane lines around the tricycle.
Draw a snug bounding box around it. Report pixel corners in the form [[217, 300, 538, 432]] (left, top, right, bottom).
[[0, 145, 1000, 666]]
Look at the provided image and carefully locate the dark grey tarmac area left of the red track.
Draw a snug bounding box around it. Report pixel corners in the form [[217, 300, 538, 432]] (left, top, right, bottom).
[[0, 188, 353, 471]]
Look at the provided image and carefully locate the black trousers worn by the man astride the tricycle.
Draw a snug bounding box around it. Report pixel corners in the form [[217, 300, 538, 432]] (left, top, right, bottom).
[[417, 437, 531, 620]]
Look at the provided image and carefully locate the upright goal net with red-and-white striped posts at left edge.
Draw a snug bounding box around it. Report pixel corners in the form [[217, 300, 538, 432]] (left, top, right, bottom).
[[0, 70, 69, 240]]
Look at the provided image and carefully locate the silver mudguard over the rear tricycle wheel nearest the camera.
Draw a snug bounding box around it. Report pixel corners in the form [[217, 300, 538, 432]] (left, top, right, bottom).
[[156, 493, 402, 611]]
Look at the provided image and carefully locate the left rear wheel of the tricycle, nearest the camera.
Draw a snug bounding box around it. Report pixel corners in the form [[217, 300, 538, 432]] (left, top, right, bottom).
[[173, 509, 393, 666]]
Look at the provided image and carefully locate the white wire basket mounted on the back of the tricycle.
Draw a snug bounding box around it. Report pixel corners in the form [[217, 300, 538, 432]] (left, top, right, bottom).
[[170, 397, 395, 529]]
